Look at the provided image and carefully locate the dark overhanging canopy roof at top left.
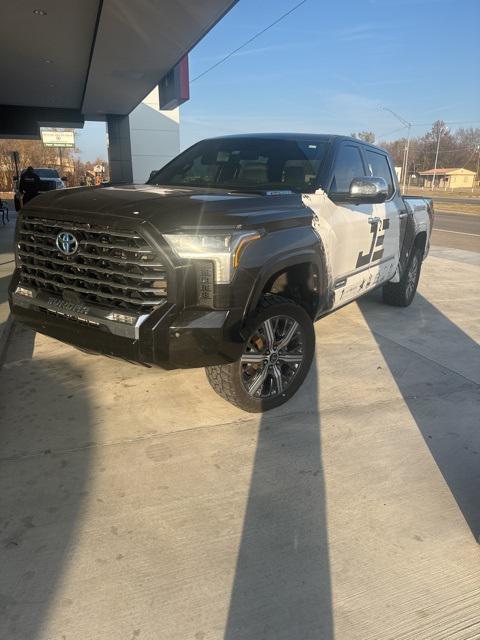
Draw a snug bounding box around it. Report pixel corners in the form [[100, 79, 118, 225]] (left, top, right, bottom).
[[0, 0, 236, 138]]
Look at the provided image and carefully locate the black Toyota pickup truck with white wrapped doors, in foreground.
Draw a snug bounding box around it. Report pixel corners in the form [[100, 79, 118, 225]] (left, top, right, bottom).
[[9, 134, 433, 412]]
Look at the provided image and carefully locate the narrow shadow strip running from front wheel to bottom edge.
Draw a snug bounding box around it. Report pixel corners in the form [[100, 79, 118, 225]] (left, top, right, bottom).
[[224, 363, 333, 640]]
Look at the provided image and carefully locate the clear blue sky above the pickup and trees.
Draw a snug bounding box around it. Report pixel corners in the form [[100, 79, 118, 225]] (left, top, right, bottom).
[[78, 0, 480, 157]]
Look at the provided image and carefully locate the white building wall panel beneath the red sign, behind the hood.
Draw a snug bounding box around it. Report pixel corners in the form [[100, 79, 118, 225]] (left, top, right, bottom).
[[130, 88, 180, 183]]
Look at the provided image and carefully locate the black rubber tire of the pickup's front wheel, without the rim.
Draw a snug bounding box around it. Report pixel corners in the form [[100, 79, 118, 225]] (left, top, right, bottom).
[[205, 294, 315, 413]]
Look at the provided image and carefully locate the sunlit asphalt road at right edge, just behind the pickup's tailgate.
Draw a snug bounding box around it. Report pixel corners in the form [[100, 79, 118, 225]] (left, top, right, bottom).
[[432, 211, 480, 253]]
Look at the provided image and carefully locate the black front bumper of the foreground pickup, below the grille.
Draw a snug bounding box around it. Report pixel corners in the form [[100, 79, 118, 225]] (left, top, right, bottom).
[[9, 276, 243, 369]]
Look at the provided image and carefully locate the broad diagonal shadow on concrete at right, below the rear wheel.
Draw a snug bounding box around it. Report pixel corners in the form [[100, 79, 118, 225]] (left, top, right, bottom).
[[359, 292, 480, 541]]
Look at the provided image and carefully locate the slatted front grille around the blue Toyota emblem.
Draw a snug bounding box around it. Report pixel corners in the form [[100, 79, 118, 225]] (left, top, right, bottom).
[[17, 216, 167, 313]]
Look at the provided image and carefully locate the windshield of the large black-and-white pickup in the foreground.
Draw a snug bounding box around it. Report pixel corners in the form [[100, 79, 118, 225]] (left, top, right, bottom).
[[148, 138, 328, 193]]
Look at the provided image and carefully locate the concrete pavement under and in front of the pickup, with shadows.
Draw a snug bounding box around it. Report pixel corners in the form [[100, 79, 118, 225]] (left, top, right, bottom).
[[0, 247, 480, 640]]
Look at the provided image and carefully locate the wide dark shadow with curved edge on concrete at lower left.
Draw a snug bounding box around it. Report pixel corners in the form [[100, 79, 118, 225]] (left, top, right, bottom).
[[0, 350, 92, 640]]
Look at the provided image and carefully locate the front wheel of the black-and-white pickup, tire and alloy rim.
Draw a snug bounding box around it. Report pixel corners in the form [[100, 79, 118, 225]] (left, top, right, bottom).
[[205, 294, 315, 413]]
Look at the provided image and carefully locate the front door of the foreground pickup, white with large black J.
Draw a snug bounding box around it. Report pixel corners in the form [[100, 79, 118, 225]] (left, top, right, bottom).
[[329, 141, 380, 307]]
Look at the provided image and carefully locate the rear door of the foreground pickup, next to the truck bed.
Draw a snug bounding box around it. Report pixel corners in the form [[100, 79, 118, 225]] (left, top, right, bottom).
[[363, 147, 403, 287]]
